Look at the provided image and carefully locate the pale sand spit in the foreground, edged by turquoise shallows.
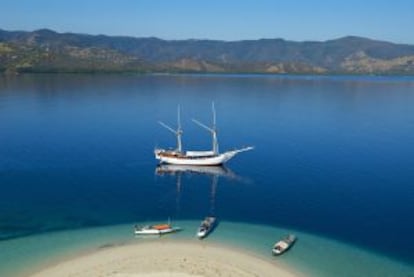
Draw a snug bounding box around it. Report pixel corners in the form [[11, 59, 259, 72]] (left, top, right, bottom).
[[31, 241, 298, 277]]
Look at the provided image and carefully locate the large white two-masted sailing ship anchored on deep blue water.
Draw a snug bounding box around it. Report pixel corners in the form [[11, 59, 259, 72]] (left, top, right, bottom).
[[154, 103, 253, 166]]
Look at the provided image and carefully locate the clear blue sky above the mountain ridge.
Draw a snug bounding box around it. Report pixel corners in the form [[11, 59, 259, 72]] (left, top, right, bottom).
[[0, 0, 414, 44]]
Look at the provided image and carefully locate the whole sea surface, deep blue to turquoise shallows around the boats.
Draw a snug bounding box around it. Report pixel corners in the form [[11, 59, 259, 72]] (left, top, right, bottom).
[[0, 74, 414, 277]]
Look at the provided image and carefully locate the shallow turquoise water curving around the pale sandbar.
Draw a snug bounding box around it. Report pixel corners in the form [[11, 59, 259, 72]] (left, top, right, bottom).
[[0, 221, 414, 277]]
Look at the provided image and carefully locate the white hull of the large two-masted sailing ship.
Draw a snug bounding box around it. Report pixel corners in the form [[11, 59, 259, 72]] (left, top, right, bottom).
[[155, 147, 253, 166]]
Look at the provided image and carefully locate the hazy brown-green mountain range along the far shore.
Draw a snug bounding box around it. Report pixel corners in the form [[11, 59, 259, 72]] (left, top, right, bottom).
[[0, 29, 414, 75]]
